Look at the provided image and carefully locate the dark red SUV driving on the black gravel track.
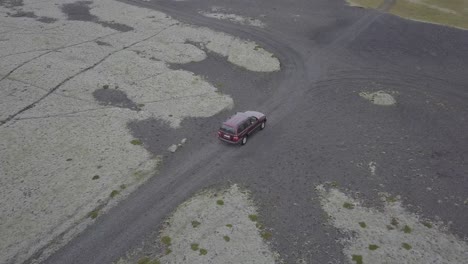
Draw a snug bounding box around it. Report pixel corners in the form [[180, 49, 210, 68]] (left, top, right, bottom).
[[218, 111, 266, 145]]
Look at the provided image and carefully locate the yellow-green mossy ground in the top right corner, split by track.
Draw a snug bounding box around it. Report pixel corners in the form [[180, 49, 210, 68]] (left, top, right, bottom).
[[347, 0, 468, 29]]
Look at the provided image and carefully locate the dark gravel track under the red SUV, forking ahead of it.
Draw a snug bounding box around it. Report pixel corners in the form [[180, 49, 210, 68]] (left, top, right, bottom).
[[37, 1, 381, 264]]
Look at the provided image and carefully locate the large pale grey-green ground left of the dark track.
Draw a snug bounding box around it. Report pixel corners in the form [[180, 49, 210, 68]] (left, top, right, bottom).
[[0, 1, 279, 263]]
